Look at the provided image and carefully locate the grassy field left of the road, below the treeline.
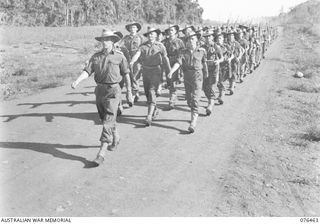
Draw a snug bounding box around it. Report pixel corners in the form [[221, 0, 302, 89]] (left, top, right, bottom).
[[0, 24, 167, 100]]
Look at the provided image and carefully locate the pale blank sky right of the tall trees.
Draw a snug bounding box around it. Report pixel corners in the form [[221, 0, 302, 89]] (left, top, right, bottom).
[[198, 0, 306, 22]]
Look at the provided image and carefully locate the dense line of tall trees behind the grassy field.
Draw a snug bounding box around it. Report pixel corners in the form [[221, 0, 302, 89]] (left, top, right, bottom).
[[0, 0, 203, 26]]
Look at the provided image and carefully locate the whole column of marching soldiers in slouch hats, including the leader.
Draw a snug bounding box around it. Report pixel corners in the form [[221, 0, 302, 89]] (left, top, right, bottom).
[[71, 22, 277, 166]]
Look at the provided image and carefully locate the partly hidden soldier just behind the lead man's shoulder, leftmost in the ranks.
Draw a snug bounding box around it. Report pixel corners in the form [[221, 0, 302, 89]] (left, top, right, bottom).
[[119, 22, 145, 106]]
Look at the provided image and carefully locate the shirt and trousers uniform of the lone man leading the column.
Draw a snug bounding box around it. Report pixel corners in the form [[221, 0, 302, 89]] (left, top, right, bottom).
[[84, 50, 129, 143]]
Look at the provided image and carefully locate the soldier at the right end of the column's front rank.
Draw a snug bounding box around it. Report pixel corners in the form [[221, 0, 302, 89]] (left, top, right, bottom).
[[168, 33, 208, 133]]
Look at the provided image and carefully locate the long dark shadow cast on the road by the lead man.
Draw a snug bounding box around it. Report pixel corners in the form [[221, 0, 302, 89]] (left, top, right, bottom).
[[0, 142, 99, 168]]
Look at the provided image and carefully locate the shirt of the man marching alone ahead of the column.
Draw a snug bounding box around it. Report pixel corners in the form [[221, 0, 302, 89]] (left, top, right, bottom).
[[84, 50, 129, 84]]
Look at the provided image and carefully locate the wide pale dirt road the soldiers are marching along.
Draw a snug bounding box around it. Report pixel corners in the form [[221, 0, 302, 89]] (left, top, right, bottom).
[[0, 30, 319, 216]]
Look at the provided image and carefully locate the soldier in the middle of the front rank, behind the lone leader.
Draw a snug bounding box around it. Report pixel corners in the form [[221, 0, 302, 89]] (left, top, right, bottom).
[[130, 28, 171, 126]]
